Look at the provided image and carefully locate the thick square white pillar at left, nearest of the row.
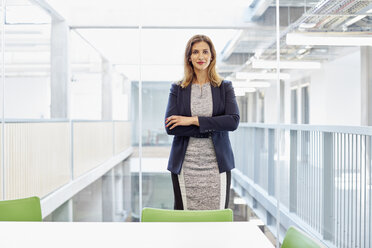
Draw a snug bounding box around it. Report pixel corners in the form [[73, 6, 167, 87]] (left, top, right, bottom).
[[50, 18, 70, 119]]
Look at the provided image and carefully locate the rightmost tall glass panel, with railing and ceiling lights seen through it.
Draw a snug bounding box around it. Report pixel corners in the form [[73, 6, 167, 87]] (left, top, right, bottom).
[[280, 0, 372, 247]]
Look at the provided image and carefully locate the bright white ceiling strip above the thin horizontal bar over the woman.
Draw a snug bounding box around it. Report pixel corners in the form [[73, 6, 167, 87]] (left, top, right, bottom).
[[46, 0, 252, 26]]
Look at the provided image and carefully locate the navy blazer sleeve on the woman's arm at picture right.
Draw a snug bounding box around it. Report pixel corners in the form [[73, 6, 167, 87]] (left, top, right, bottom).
[[198, 83, 240, 133]]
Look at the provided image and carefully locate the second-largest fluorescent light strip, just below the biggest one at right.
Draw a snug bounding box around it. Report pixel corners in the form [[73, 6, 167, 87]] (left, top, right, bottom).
[[252, 60, 321, 69]]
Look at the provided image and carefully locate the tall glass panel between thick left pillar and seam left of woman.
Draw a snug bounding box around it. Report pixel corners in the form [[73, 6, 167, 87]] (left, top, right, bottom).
[[70, 28, 139, 221]]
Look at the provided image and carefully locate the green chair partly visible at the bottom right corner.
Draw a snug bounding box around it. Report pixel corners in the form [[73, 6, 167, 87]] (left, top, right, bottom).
[[282, 226, 325, 248]]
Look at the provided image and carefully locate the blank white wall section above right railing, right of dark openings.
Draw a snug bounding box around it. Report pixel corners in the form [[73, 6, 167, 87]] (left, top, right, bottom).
[[309, 50, 361, 125]]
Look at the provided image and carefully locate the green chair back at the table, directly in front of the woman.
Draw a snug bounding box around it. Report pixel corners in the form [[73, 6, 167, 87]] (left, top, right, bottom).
[[141, 208, 233, 222]]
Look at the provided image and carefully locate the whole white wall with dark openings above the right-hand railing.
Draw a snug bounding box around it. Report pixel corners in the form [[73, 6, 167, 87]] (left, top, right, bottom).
[[265, 48, 362, 126]]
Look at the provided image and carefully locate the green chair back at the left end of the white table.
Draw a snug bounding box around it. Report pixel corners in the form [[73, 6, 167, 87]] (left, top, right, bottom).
[[0, 196, 42, 221]]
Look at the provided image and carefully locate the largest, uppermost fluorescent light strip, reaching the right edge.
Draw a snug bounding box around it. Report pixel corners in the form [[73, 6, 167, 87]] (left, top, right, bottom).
[[286, 32, 372, 46]]
